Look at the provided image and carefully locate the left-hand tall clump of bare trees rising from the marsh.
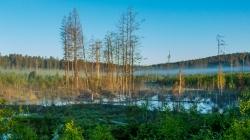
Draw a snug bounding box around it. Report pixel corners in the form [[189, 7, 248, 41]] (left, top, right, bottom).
[[61, 9, 84, 89]]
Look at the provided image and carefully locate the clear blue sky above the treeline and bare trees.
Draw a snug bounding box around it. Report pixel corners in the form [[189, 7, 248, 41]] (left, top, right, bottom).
[[0, 0, 250, 65]]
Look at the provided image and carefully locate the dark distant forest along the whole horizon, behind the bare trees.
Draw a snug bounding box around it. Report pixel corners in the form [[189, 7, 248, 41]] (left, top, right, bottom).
[[0, 53, 250, 70]]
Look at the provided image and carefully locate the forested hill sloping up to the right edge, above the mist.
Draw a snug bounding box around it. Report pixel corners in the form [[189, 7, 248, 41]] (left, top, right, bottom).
[[147, 52, 250, 69]]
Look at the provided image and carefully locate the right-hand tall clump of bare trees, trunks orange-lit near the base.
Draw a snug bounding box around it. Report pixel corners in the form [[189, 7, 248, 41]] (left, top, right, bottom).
[[118, 8, 140, 97]]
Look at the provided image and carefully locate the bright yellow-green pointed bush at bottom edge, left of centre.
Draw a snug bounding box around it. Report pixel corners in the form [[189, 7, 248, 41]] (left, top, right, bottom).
[[60, 120, 84, 140]]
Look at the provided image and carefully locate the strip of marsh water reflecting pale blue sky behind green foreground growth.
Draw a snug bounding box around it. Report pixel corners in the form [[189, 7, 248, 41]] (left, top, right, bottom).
[[38, 89, 238, 113]]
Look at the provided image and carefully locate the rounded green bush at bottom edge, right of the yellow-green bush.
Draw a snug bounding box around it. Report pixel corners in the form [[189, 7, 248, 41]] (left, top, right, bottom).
[[90, 125, 114, 140]]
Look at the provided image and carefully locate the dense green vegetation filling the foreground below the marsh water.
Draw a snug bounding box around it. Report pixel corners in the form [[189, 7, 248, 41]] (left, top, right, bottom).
[[0, 89, 250, 140]]
